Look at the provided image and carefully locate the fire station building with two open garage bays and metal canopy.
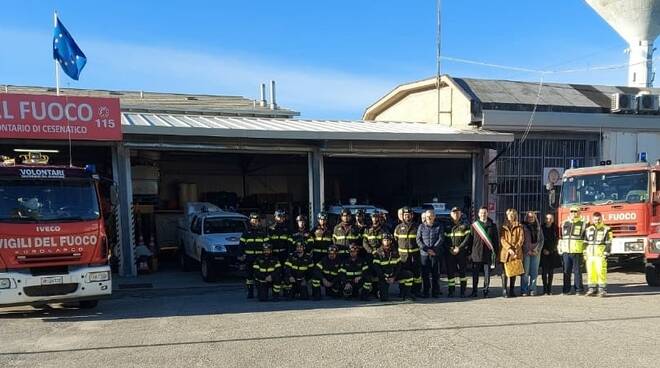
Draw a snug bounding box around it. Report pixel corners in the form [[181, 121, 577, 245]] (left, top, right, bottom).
[[0, 86, 513, 275]]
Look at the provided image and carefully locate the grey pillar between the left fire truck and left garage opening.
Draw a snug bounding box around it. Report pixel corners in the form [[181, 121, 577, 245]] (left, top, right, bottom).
[[112, 143, 137, 276]]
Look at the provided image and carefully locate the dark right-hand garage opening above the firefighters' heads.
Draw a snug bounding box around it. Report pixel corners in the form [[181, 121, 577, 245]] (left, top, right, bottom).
[[324, 157, 472, 213]]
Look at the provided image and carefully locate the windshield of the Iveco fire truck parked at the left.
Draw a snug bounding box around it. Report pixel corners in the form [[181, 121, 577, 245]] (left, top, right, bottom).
[[0, 179, 100, 222]]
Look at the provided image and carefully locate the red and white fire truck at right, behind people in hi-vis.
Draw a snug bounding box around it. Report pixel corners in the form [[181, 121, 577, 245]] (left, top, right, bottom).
[[559, 162, 660, 286]]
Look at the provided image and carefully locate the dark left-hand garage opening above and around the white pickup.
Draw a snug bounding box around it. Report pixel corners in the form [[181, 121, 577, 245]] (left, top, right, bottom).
[[131, 150, 309, 269]]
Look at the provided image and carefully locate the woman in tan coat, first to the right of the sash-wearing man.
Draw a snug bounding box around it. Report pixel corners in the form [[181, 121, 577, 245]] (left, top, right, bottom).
[[500, 208, 525, 298]]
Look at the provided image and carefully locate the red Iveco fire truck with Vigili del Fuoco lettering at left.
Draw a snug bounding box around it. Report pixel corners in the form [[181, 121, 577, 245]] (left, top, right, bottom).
[[0, 152, 112, 308]]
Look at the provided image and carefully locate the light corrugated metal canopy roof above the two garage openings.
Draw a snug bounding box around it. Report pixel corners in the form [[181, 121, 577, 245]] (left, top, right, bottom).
[[122, 112, 513, 142]]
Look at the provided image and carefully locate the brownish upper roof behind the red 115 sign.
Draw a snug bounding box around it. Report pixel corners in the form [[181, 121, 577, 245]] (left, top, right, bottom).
[[0, 85, 300, 117]]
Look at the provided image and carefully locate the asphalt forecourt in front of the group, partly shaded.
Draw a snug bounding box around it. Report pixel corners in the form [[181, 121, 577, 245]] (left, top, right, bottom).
[[0, 272, 660, 368]]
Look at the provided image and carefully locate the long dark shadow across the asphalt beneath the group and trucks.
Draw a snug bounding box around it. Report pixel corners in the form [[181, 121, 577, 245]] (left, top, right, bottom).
[[0, 264, 660, 322]]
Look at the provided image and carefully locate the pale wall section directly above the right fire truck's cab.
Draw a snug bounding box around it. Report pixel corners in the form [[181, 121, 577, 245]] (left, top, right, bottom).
[[602, 131, 660, 164]]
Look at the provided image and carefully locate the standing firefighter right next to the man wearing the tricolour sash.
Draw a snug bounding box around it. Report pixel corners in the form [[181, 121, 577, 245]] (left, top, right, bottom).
[[445, 207, 470, 298]]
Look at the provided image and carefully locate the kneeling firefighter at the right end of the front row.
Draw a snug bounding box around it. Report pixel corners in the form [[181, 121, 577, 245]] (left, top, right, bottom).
[[373, 233, 413, 302]]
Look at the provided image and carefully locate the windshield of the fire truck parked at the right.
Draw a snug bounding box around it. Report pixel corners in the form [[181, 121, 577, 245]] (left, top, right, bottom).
[[561, 172, 649, 205]]
